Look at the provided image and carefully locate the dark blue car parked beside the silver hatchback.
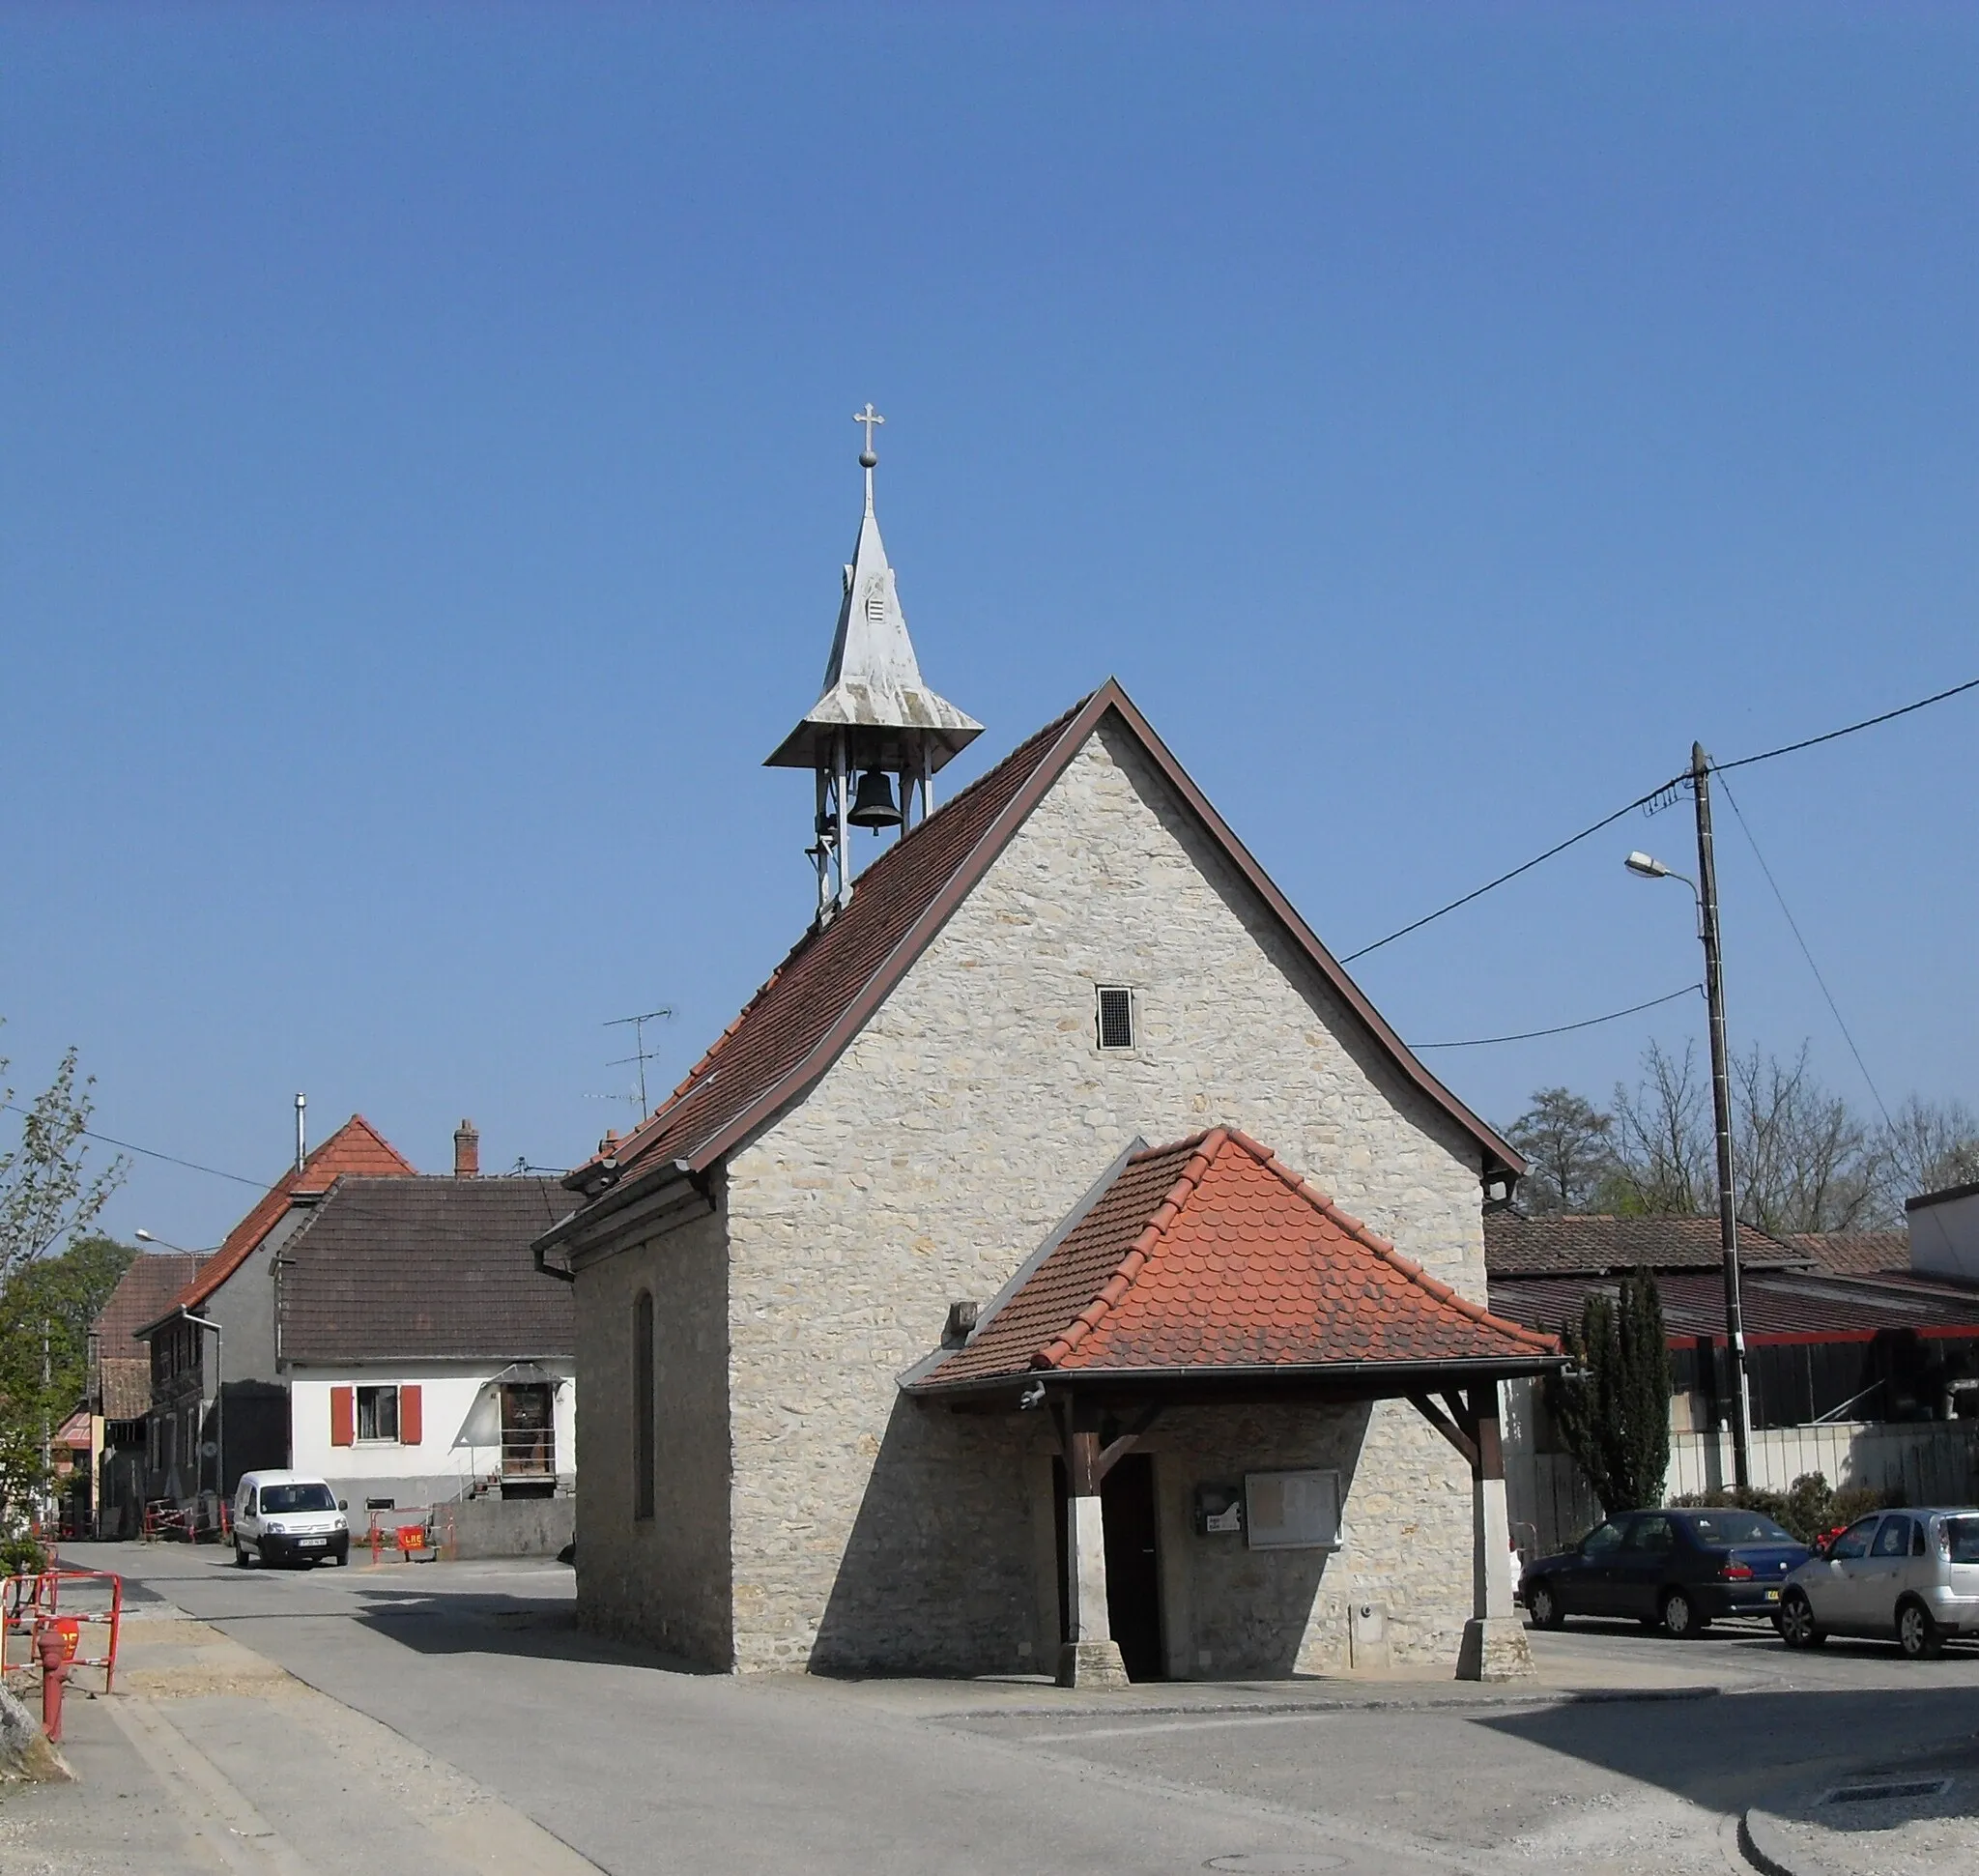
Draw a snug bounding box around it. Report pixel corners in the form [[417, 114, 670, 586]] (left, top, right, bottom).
[[1518, 1508, 1813, 1636]]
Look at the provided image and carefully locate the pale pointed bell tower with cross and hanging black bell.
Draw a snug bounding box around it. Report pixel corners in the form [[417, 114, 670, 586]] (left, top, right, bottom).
[[764, 404, 984, 922]]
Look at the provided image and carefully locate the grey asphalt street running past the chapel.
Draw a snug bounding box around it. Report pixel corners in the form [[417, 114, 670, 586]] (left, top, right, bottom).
[[15, 1545, 1979, 1876]]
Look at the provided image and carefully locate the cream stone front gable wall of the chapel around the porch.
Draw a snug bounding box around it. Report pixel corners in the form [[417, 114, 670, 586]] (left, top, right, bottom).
[[724, 733, 1484, 1672]]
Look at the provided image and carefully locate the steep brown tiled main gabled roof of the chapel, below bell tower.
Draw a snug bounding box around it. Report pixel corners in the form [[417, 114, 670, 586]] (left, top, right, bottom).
[[566, 678, 1526, 1223]]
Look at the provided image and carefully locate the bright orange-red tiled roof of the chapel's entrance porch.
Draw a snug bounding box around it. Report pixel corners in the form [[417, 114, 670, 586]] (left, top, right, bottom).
[[910, 1128, 1556, 1391]]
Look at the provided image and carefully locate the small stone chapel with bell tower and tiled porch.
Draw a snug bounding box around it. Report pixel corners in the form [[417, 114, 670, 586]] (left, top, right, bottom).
[[536, 433, 1558, 1680]]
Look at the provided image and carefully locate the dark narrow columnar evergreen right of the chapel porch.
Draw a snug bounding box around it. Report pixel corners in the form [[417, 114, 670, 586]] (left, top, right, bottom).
[[1548, 1270, 1671, 1515]]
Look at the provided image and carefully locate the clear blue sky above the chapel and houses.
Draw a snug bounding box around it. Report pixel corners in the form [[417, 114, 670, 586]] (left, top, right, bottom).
[[0, 4, 1979, 1245]]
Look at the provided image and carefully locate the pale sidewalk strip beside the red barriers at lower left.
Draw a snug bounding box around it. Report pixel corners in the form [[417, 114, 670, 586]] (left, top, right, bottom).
[[0, 1604, 595, 1876]]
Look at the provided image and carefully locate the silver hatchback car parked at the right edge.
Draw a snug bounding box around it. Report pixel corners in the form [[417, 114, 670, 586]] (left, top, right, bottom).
[[1775, 1508, 1979, 1660]]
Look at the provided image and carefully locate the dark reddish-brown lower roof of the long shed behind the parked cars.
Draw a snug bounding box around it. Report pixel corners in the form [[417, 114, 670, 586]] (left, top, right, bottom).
[[1490, 1268, 1979, 1342]]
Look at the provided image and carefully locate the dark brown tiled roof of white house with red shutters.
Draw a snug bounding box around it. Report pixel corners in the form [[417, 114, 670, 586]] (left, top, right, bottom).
[[281, 1177, 578, 1362]]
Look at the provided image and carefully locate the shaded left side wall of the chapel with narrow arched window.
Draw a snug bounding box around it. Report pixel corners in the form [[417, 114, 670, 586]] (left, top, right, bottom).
[[576, 1213, 734, 1668]]
